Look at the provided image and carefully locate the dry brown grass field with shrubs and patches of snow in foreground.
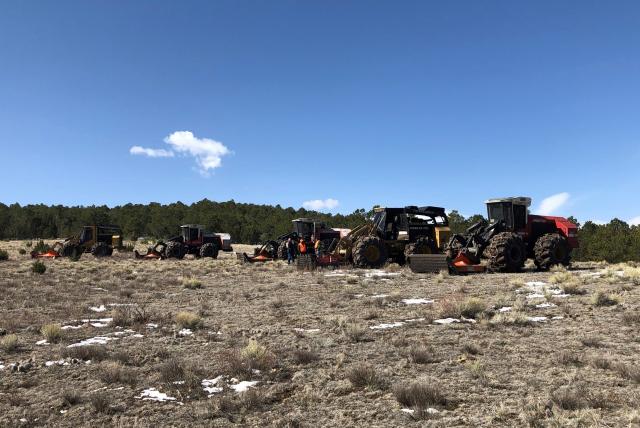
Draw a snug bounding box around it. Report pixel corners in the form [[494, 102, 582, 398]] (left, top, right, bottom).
[[0, 242, 640, 427]]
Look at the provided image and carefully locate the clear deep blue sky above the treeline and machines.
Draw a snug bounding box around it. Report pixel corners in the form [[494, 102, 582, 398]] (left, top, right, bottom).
[[0, 1, 640, 221]]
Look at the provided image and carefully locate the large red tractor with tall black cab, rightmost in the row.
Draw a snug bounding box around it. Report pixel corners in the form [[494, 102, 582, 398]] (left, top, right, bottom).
[[446, 197, 578, 272]]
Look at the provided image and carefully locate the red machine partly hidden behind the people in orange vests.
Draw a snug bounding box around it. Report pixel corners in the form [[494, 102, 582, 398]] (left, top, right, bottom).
[[242, 218, 341, 262]]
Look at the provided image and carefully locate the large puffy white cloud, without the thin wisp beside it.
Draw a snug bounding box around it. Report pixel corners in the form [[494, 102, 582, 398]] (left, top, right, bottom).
[[164, 131, 231, 175]]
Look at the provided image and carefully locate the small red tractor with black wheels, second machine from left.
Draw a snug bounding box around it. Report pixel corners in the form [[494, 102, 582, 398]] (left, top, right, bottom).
[[164, 224, 222, 259]]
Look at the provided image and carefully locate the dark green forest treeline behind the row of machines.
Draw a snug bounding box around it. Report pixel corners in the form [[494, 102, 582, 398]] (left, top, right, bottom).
[[0, 199, 640, 262]]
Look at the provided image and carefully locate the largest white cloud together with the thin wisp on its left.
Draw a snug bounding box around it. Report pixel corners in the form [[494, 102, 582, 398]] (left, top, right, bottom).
[[129, 131, 231, 176]]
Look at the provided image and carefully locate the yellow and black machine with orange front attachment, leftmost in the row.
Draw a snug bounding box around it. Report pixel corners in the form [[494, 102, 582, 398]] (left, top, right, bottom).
[[31, 225, 122, 258]]
